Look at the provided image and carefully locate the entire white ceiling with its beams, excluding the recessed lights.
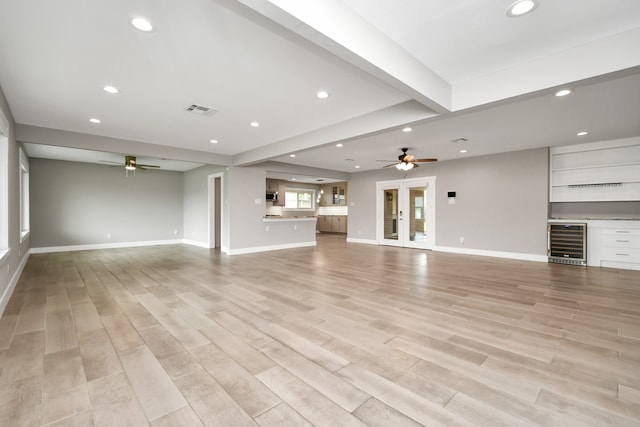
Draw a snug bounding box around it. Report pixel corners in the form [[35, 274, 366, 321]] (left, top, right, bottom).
[[0, 0, 640, 172]]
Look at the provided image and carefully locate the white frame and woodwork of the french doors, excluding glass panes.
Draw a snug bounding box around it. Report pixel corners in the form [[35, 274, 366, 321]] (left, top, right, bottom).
[[376, 176, 436, 249]]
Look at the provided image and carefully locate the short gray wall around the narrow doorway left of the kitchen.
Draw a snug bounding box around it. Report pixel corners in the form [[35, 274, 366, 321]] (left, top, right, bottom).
[[183, 165, 229, 249]]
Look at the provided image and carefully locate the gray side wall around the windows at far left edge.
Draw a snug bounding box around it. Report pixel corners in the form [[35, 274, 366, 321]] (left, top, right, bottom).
[[0, 85, 30, 314]]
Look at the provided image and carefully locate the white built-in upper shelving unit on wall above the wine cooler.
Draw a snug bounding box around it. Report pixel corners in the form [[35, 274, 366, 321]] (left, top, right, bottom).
[[549, 137, 640, 203]]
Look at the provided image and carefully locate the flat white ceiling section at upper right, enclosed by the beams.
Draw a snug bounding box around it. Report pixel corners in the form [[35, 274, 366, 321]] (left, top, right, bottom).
[[344, 0, 640, 84]]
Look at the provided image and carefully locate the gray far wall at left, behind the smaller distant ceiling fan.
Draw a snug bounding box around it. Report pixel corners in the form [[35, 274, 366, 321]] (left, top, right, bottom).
[[30, 159, 183, 248]]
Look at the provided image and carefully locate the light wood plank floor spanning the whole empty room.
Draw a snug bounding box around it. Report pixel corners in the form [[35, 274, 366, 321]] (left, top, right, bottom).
[[0, 235, 640, 427]]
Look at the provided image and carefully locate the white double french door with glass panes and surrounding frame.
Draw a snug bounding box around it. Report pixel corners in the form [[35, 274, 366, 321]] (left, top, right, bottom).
[[376, 177, 436, 249]]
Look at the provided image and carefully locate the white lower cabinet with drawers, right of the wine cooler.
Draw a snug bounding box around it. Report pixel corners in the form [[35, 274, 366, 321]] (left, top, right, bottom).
[[587, 220, 640, 270]]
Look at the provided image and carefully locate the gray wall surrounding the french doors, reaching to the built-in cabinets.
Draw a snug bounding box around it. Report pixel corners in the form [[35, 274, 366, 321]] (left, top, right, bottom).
[[348, 148, 549, 255]]
